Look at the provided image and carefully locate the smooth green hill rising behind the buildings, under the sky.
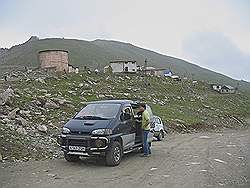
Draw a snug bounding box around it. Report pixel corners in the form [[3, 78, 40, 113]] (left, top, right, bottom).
[[0, 38, 250, 90]]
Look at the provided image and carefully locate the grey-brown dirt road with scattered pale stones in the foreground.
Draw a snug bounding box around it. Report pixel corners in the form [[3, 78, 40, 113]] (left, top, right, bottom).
[[0, 130, 250, 188]]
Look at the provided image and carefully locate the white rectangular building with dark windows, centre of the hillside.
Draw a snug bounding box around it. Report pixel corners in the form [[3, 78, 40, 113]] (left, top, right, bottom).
[[110, 61, 137, 73]]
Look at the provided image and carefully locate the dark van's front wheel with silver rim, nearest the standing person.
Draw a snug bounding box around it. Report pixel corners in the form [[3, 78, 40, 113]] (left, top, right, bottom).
[[106, 141, 122, 166]]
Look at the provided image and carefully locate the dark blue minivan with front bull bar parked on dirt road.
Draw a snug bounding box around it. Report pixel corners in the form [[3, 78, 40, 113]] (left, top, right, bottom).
[[59, 100, 153, 166]]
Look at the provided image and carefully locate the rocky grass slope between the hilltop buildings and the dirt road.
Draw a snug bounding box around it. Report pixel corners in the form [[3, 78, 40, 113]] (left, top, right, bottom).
[[0, 71, 250, 162]]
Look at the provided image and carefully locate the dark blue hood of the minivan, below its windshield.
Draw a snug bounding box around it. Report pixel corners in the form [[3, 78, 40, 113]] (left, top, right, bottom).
[[64, 119, 113, 134]]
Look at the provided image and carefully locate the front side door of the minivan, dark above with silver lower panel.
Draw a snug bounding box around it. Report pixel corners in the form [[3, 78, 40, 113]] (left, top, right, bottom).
[[120, 106, 136, 150]]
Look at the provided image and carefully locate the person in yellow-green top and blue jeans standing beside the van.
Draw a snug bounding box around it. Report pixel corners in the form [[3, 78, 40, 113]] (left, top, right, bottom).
[[139, 103, 151, 157]]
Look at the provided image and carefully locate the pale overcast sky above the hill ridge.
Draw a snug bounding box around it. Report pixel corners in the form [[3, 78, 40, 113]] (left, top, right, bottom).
[[0, 0, 250, 81]]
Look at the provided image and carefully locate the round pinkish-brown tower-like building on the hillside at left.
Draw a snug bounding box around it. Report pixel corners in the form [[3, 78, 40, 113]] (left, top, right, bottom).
[[38, 50, 69, 72]]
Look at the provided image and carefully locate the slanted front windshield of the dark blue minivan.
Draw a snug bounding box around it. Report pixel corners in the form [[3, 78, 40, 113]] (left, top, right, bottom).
[[74, 103, 121, 120]]
